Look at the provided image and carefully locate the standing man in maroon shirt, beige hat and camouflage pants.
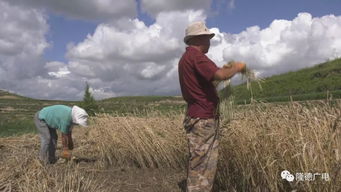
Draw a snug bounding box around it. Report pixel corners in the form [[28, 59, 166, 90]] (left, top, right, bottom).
[[178, 22, 245, 192]]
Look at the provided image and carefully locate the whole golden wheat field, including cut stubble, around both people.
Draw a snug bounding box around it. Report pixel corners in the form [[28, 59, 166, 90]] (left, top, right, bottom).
[[0, 100, 341, 192]]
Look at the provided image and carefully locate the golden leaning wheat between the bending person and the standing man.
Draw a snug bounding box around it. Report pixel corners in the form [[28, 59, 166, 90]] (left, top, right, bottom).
[[90, 115, 187, 168]]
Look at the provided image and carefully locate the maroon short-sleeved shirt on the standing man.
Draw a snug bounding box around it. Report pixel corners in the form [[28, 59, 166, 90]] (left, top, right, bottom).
[[178, 47, 219, 119]]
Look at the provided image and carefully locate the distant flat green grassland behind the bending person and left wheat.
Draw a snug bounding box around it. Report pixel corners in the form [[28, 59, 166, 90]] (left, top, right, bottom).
[[0, 90, 185, 137]]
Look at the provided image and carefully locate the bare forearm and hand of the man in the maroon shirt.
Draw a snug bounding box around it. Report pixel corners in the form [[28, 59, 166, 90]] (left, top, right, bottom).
[[214, 62, 246, 81]]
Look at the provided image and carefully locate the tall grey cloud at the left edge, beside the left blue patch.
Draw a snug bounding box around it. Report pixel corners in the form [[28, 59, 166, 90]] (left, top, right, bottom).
[[0, 2, 48, 81]]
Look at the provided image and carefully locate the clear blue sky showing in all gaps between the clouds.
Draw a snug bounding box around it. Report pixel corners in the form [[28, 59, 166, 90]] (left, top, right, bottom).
[[44, 0, 341, 62]]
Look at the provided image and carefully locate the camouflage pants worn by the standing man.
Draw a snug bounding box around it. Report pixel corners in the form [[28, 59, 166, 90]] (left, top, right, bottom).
[[184, 117, 219, 192]]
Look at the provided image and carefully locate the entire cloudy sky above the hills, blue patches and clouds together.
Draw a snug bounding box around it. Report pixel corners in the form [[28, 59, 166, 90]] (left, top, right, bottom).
[[0, 0, 341, 100]]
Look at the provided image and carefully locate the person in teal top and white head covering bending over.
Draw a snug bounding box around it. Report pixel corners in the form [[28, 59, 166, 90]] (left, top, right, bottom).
[[34, 105, 88, 164]]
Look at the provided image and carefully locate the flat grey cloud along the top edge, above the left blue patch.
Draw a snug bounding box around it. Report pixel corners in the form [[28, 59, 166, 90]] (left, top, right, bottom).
[[4, 0, 137, 21]]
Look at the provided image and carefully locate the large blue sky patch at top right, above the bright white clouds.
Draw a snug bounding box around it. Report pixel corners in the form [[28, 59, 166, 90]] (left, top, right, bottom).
[[208, 0, 341, 33]]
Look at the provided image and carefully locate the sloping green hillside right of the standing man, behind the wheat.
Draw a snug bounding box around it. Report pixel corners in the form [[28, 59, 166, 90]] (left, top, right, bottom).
[[232, 59, 341, 102]]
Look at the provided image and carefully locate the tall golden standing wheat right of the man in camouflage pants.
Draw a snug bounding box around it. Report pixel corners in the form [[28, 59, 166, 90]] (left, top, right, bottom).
[[218, 101, 341, 192]]
